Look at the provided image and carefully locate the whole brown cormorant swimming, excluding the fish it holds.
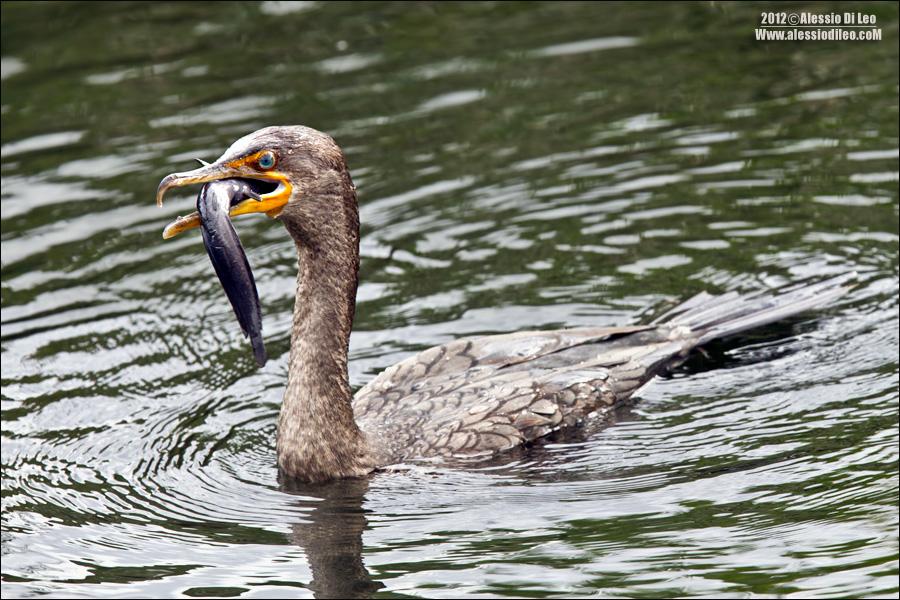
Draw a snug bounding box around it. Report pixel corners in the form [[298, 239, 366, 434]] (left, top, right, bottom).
[[157, 126, 853, 482]]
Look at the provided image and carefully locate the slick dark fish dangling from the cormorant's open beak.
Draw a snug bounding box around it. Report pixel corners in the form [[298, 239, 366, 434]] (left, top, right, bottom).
[[197, 179, 266, 367]]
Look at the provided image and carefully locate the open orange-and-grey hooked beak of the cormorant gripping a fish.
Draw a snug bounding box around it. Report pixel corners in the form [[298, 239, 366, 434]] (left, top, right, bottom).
[[156, 157, 293, 239]]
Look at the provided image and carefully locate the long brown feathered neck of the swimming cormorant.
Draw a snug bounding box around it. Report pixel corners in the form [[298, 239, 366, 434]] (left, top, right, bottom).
[[276, 188, 374, 482]]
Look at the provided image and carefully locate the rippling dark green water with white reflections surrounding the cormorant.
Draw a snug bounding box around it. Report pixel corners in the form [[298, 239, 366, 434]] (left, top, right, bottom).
[[0, 2, 900, 598]]
